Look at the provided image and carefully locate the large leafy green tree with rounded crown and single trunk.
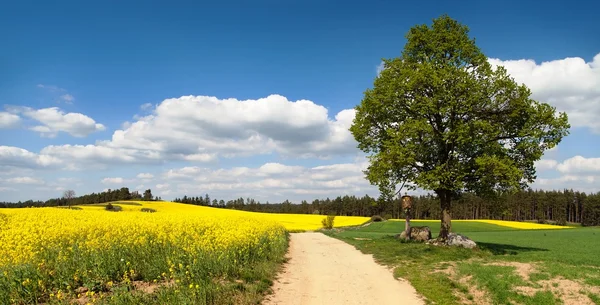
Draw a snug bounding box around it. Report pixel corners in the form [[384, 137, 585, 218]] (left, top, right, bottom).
[[350, 15, 570, 238]]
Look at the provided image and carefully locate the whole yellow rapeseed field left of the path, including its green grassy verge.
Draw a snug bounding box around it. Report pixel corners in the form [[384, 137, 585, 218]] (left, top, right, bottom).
[[0, 201, 368, 304]]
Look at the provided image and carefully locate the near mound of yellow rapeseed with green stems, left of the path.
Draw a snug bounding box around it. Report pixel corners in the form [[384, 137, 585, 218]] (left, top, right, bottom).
[[0, 202, 287, 304]]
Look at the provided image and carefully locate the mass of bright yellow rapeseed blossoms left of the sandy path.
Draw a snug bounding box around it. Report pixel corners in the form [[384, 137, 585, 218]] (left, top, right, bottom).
[[0, 201, 368, 299]]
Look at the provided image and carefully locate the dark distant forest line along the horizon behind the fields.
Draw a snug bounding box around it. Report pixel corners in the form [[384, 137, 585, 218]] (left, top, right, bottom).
[[0, 187, 600, 226]]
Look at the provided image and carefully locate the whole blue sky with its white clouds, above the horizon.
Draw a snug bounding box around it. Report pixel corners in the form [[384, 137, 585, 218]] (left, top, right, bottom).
[[0, 0, 600, 201]]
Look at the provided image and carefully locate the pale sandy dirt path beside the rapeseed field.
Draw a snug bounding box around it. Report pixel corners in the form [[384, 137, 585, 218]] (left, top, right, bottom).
[[263, 233, 424, 305]]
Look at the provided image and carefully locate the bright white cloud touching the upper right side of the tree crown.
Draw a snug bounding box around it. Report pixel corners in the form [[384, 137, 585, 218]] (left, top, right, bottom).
[[489, 54, 600, 134]]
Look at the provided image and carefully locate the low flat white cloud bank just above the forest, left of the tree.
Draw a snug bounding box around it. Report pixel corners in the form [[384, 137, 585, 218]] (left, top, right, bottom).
[[162, 162, 377, 200]]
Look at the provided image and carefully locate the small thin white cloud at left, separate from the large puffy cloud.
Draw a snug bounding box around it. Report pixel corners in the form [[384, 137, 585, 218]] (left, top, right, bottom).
[[12, 107, 106, 138]]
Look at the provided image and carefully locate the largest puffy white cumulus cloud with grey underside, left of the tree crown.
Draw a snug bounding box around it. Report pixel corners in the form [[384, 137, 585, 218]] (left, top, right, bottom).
[[102, 95, 356, 158]]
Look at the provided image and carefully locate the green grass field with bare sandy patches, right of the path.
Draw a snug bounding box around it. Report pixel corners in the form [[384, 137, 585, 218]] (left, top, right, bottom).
[[327, 221, 600, 304]]
